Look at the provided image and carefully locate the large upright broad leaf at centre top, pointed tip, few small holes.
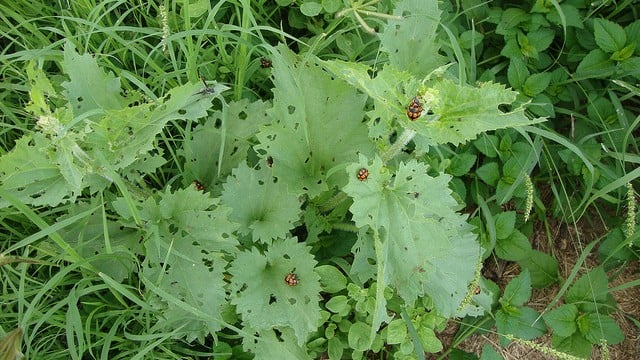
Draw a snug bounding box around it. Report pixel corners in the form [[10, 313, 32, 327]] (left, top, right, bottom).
[[256, 46, 373, 198]]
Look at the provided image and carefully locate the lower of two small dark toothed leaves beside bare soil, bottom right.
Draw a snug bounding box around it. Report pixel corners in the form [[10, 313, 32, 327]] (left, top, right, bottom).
[[496, 307, 547, 346]]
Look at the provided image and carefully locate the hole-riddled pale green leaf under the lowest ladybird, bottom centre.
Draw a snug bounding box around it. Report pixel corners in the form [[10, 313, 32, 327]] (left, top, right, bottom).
[[229, 238, 321, 345]]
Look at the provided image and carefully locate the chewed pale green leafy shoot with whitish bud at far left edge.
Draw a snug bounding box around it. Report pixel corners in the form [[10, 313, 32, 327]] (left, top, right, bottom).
[[0, 43, 218, 207]]
